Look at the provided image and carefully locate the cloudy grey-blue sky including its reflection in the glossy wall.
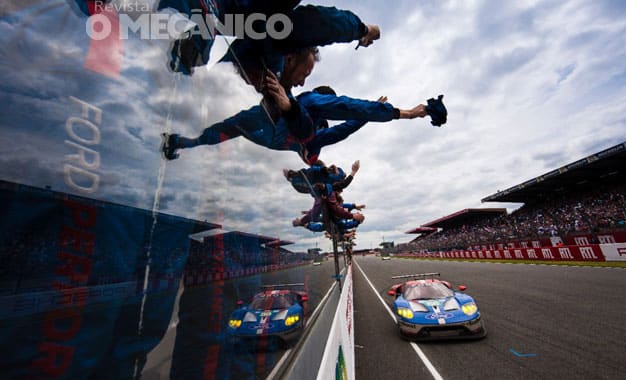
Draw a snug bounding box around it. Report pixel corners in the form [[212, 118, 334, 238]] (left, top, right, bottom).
[[0, 0, 626, 254]]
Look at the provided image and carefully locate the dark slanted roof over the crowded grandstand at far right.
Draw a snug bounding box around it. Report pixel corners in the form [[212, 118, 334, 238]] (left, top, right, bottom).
[[481, 142, 626, 203]]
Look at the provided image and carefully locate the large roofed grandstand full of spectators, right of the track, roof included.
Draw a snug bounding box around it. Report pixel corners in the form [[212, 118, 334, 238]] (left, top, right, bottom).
[[400, 142, 626, 251]]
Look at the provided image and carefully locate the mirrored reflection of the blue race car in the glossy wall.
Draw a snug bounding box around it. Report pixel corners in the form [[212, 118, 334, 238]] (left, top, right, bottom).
[[228, 284, 308, 343]]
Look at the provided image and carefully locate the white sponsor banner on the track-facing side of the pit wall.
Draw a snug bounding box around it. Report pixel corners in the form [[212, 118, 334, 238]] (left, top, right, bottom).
[[317, 265, 355, 380]]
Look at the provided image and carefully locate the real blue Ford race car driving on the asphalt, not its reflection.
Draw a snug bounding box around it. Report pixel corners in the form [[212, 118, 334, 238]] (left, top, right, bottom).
[[388, 273, 487, 340]]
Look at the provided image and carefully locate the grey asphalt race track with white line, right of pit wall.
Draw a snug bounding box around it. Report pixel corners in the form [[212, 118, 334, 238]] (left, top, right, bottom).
[[353, 256, 626, 379]]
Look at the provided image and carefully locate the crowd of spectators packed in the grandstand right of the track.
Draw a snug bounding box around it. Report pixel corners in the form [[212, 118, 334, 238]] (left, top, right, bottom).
[[411, 185, 626, 250]]
